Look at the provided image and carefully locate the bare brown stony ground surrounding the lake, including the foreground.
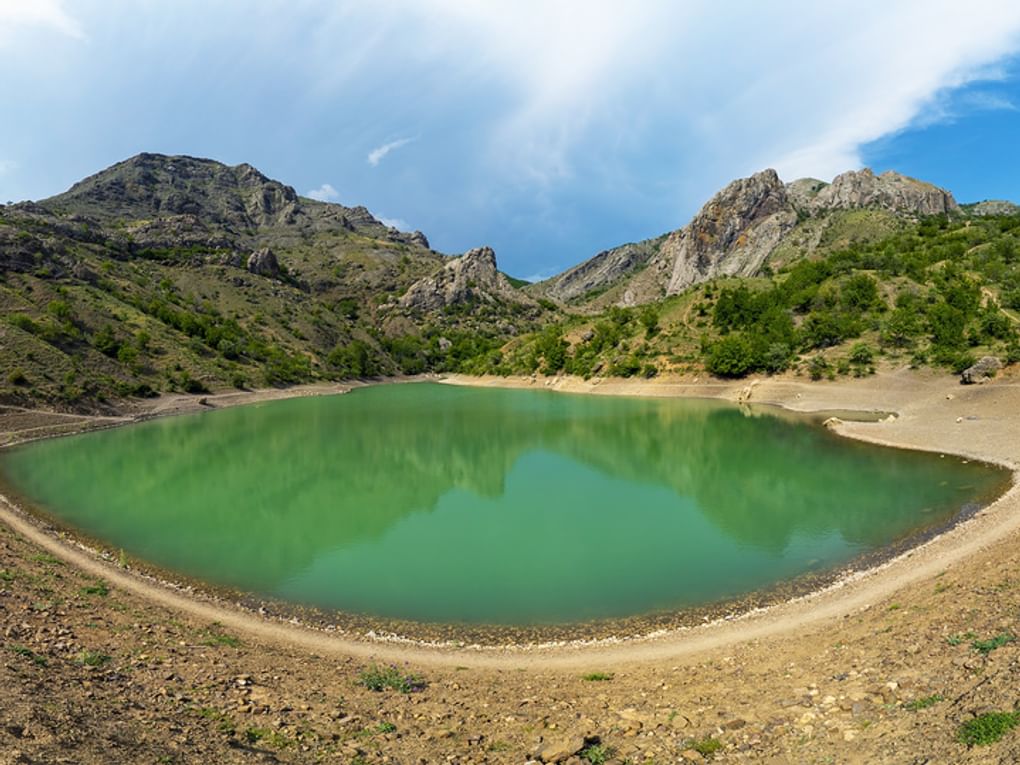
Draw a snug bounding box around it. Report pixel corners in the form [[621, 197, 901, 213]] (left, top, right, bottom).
[[0, 371, 1020, 763]]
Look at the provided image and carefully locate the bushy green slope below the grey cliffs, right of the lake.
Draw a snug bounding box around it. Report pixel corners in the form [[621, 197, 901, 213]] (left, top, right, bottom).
[[496, 216, 1020, 379]]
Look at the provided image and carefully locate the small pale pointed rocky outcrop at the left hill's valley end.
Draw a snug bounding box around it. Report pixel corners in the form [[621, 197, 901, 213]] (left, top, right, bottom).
[[400, 247, 533, 312]]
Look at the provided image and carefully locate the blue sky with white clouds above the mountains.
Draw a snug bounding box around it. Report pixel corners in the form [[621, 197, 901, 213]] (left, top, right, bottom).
[[0, 0, 1020, 278]]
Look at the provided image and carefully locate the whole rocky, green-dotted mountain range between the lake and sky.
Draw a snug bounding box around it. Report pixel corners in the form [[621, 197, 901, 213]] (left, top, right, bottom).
[[0, 154, 1020, 409]]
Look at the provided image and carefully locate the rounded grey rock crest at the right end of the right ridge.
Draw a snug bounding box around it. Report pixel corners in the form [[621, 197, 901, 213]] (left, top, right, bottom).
[[806, 167, 959, 215]]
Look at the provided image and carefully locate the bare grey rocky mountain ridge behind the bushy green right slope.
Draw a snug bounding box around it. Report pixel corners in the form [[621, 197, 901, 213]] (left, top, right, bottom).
[[544, 169, 959, 305]]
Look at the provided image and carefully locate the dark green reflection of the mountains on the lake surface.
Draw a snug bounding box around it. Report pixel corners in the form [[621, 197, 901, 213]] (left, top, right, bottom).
[[5, 385, 995, 592]]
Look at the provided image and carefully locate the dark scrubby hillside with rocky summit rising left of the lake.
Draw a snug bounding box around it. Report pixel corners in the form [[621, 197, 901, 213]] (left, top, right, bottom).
[[0, 154, 545, 407]]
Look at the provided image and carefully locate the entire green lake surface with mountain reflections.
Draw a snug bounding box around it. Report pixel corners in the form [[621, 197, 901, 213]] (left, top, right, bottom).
[[0, 384, 1006, 624]]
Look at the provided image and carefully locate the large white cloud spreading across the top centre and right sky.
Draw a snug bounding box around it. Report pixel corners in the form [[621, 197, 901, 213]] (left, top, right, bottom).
[[377, 0, 1020, 186]]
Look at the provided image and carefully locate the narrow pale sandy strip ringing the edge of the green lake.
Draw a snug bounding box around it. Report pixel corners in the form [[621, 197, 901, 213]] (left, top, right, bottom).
[[0, 371, 1020, 667]]
